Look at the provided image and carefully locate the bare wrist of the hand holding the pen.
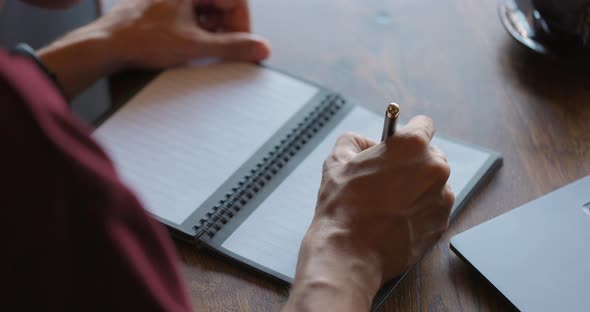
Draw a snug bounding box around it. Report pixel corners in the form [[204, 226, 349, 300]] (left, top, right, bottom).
[[286, 220, 383, 311]]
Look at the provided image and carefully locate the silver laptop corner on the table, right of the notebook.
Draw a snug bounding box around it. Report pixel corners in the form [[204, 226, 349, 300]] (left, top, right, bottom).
[[451, 177, 590, 312]]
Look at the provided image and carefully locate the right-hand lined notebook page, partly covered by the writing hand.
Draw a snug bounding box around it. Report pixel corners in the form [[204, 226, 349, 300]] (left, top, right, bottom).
[[222, 107, 489, 279]]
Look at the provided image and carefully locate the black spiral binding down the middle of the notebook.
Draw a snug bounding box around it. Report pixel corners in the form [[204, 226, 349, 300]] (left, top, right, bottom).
[[194, 94, 345, 238]]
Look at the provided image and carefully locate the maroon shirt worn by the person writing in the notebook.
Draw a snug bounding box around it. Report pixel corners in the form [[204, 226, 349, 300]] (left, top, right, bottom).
[[0, 50, 190, 311]]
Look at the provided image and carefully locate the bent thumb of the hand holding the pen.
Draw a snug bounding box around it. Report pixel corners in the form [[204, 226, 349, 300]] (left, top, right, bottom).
[[324, 132, 377, 167]]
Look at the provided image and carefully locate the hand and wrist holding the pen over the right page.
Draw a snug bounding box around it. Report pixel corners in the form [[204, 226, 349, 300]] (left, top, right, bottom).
[[286, 116, 454, 311]]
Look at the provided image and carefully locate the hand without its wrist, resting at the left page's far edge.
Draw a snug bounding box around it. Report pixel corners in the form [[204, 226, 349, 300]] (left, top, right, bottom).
[[105, 0, 270, 68]]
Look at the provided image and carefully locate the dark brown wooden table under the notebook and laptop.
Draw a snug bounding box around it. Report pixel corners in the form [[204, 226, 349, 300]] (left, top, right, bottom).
[[134, 0, 590, 311]]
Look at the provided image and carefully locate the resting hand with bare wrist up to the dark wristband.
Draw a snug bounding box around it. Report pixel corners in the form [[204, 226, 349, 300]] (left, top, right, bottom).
[[38, 0, 270, 98]]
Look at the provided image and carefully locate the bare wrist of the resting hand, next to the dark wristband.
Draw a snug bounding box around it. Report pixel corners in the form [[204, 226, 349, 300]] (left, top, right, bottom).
[[38, 21, 124, 99]]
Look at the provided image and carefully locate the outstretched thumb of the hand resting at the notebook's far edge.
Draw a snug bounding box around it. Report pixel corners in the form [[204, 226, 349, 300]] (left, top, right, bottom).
[[197, 32, 270, 62]]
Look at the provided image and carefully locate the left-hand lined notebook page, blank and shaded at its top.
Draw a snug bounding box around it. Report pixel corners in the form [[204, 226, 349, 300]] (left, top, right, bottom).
[[94, 63, 318, 224]]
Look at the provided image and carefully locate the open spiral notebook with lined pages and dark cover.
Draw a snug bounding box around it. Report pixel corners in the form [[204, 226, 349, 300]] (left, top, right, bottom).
[[94, 63, 501, 308]]
